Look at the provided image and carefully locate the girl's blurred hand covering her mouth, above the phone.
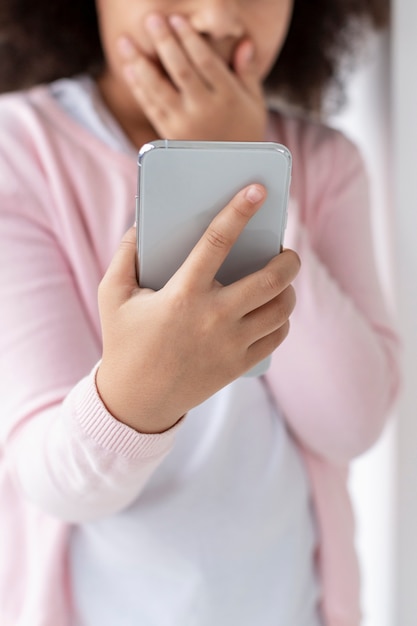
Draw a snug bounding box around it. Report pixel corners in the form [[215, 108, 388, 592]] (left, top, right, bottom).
[[120, 15, 266, 141]]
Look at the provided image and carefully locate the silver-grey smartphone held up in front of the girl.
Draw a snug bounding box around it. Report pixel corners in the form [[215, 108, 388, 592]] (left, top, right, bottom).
[[136, 140, 291, 376]]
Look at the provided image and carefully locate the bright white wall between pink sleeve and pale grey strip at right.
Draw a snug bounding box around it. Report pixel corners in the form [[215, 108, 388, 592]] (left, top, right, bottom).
[[330, 30, 394, 626]]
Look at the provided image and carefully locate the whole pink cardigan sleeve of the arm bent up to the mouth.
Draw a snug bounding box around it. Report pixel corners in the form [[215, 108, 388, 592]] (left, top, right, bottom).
[[267, 127, 399, 463]]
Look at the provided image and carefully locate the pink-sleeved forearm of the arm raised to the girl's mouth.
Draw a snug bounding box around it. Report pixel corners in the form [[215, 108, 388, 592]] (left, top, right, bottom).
[[268, 217, 399, 462]]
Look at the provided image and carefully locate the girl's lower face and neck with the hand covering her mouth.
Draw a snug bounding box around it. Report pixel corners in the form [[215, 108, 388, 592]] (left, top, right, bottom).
[[97, 0, 293, 147]]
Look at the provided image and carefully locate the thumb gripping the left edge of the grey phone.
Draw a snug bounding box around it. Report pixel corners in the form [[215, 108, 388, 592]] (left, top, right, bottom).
[[100, 225, 139, 304]]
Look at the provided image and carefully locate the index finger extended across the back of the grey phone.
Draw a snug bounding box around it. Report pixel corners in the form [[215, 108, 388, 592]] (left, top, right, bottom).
[[182, 185, 266, 281]]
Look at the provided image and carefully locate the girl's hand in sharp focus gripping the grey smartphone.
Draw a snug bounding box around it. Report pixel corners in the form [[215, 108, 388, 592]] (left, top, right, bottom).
[[97, 185, 299, 433]]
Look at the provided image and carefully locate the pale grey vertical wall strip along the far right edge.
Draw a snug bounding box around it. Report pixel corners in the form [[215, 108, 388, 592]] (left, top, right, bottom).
[[392, 0, 417, 626]]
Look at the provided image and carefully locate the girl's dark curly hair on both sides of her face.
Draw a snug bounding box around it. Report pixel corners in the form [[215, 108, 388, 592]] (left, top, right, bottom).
[[0, 0, 389, 111]]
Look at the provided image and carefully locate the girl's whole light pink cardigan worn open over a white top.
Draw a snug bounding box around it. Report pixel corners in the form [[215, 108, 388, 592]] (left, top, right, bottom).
[[0, 87, 398, 626]]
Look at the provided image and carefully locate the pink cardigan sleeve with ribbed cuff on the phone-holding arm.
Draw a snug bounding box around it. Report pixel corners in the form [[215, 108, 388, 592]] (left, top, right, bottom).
[[0, 182, 175, 522]]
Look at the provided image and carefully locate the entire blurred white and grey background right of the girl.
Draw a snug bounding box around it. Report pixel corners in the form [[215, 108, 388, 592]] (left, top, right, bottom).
[[330, 0, 417, 626]]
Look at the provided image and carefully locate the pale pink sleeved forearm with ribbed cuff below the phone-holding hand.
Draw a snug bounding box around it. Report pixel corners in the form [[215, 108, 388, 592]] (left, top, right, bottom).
[[7, 370, 174, 522]]
